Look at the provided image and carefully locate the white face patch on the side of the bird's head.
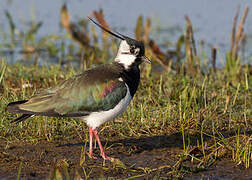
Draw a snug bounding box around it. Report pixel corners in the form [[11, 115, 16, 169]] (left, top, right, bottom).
[[115, 40, 139, 69]]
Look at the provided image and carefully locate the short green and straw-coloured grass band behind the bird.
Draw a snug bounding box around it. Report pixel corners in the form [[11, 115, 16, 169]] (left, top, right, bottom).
[[0, 58, 252, 177]]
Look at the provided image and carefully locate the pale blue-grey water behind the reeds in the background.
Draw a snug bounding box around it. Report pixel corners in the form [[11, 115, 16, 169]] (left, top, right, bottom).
[[0, 0, 252, 64]]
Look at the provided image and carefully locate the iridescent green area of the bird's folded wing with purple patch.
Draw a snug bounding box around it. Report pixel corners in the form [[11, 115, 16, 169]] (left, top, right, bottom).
[[55, 80, 127, 114]]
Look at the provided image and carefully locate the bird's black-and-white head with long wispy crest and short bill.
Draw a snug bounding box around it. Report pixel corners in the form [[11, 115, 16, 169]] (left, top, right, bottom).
[[89, 18, 151, 70]]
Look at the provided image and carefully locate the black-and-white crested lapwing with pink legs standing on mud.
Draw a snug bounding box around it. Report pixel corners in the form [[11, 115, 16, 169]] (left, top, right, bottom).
[[7, 17, 151, 160]]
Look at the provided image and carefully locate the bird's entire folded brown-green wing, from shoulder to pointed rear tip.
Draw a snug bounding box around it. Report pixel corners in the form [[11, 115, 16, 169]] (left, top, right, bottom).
[[7, 65, 127, 117]]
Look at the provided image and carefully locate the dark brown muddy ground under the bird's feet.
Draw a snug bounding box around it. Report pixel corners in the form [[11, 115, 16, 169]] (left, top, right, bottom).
[[0, 134, 252, 179]]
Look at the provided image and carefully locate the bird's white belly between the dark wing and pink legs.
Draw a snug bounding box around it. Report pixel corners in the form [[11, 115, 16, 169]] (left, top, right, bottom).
[[82, 85, 131, 129]]
